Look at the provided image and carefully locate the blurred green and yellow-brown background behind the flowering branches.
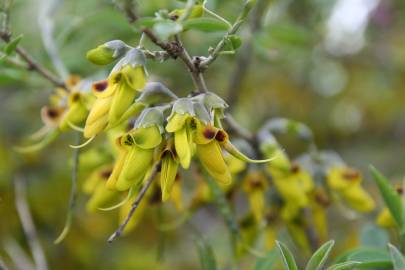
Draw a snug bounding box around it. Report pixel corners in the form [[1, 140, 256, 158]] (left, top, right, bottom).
[[0, 0, 405, 269]]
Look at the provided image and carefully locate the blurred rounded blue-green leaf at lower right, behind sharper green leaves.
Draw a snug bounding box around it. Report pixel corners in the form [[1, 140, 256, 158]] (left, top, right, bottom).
[[360, 223, 389, 248]]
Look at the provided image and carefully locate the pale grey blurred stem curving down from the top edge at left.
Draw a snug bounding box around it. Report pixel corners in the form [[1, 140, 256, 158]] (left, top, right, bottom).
[[38, 0, 69, 80]]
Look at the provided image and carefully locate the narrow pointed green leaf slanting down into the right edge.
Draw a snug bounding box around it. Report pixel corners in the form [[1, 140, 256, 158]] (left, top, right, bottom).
[[370, 166, 404, 229]]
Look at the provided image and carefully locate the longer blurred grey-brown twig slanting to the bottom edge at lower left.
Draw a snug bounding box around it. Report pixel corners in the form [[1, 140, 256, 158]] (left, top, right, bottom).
[[14, 177, 48, 270]]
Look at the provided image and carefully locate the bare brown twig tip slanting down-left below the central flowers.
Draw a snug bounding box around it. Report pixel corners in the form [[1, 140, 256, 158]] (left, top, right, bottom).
[[107, 161, 161, 243]]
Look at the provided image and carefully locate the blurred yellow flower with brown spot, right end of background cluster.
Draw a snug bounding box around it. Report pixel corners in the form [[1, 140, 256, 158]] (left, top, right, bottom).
[[327, 166, 375, 212]]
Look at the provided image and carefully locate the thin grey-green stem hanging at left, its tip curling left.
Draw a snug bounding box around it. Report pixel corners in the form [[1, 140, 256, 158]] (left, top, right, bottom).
[[54, 132, 81, 244]]
